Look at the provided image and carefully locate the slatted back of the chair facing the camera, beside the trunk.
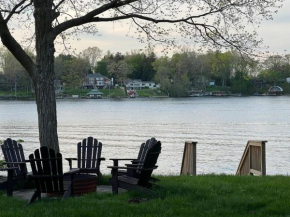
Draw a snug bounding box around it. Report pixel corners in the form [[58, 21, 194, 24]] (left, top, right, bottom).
[[77, 137, 103, 168]]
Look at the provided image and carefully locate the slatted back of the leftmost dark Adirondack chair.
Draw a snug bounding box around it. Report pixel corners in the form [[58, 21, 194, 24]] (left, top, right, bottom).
[[1, 138, 27, 176]]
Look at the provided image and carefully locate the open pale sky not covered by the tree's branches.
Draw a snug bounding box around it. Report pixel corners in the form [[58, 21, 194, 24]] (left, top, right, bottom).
[[57, 0, 290, 56]]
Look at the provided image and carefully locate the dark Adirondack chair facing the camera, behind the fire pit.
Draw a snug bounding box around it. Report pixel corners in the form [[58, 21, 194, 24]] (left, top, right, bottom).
[[66, 137, 105, 181]]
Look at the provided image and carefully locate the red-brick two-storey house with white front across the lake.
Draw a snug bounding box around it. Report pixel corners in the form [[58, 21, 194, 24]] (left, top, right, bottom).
[[82, 73, 111, 89]]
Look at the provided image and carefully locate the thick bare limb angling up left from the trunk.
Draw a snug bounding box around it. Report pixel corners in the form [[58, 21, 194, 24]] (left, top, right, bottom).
[[0, 13, 36, 82]]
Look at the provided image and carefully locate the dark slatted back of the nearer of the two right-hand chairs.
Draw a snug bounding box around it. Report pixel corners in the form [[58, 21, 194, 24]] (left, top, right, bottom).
[[138, 141, 161, 186]]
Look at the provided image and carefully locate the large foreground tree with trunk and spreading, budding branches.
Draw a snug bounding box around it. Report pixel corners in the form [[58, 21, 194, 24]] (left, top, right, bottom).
[[0, 0, 282, 151]]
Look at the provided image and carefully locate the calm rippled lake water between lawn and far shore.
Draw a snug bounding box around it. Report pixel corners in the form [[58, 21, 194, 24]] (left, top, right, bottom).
[[0, 96, 290, 175]]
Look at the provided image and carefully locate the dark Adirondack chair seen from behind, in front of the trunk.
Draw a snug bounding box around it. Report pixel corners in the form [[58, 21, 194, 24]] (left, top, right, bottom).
[[27, 147, 79, 204]]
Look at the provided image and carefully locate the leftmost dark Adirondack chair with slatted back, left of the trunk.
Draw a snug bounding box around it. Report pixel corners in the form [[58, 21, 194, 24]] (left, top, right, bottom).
[[1, 138, 28, 190]]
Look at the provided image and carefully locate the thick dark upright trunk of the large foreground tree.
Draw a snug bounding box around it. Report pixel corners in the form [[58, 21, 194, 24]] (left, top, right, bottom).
[[34, 0, 59, 152]]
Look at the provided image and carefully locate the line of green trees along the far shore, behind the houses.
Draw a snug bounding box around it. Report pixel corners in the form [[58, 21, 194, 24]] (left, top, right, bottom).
[[0, 47, 290, 97]]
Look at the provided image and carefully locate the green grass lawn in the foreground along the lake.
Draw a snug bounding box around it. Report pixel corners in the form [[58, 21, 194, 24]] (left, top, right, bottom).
[[0, 175, 290, 217]]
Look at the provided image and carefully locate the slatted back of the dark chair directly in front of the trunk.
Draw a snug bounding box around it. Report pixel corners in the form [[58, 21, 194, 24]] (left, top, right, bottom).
[[29, 147, 64, 193]]
